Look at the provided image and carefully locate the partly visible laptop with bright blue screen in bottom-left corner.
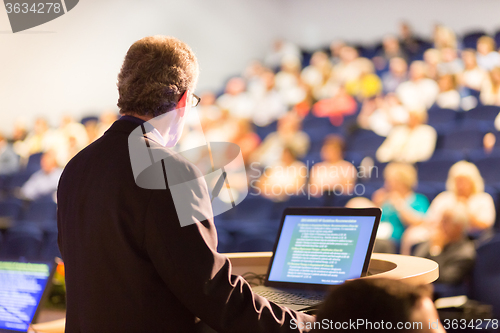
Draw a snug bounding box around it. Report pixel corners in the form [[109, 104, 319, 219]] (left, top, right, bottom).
[[0, 260, 57, 333]]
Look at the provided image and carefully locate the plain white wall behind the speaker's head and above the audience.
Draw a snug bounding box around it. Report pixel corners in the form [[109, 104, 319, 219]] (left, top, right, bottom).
[[0, 0, 500, 133]]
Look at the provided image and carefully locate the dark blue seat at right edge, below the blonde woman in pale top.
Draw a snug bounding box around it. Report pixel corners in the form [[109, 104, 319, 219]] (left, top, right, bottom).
[[472, 234, 500, 318]]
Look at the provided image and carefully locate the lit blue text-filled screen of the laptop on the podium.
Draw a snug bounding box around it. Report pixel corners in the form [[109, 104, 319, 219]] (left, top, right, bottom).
[[268, 215, 376, 285]]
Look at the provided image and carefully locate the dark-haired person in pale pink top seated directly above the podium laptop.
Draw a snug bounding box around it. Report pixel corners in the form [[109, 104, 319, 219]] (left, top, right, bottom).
[[309, 134, 357, 196]]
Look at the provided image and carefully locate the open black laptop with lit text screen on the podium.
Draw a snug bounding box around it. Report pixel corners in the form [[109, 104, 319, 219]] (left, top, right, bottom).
[[253, 208, 381, 310]]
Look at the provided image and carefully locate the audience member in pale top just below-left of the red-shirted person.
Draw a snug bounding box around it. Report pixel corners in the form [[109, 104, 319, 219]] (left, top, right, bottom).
[[251, 112, 310, 167]]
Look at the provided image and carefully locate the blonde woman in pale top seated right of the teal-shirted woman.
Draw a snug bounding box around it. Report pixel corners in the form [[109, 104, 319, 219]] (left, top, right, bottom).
[[401, 161, 496, 254]]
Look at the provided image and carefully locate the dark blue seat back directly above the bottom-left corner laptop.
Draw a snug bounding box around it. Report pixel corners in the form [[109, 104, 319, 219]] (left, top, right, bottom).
[[1, 222, 43, 259]]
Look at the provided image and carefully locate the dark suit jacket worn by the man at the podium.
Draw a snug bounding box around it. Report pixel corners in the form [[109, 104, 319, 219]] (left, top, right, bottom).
[[57, 119, 312, 333]]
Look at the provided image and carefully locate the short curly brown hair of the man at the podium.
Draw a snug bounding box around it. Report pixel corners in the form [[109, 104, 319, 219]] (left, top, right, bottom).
[[117, 36, 199, 117]]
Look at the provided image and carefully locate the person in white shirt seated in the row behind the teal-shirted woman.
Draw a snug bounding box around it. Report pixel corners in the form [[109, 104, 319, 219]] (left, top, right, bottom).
[[376, 111, 437, 163]]
